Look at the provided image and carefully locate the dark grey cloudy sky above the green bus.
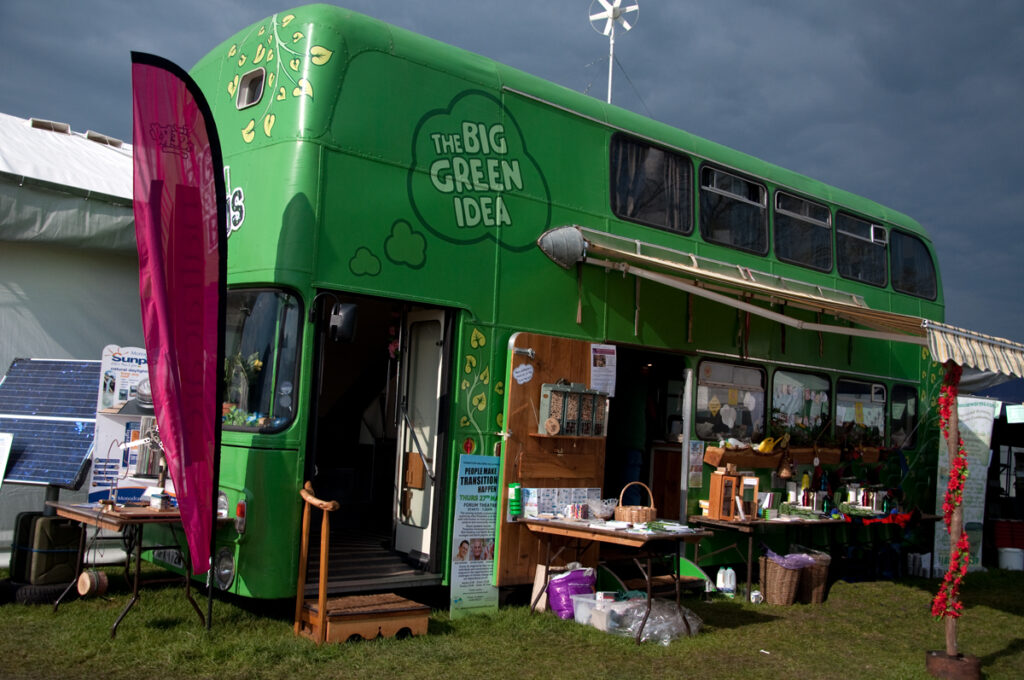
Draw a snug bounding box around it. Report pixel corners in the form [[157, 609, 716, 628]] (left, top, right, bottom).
[[6, 0, 1024, 341]]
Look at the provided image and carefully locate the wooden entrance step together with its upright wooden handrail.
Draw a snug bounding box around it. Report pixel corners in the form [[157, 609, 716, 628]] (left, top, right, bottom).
[[294, 481, 430, 644]]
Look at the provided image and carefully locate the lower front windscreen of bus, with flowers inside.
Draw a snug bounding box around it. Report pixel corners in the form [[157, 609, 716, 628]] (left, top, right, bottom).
[[223, 289, 299, 432]]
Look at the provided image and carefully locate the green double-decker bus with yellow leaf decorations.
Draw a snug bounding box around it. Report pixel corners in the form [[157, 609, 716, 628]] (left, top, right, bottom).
[[172, 5, 943, 598]]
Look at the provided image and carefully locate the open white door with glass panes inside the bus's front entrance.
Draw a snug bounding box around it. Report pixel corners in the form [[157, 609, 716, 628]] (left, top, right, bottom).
[[394, 309, 444, 560]]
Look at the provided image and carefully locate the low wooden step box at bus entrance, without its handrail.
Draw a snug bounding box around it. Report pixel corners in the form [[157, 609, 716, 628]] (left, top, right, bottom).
[[296, 593, 430, 643]]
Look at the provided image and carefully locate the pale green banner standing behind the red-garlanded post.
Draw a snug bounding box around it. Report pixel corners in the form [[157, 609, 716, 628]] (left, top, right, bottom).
[[933, 396, 999, 576]]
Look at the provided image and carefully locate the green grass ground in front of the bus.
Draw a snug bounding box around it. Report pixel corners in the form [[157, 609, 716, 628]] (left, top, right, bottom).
[[0, 569, 1024, 680]]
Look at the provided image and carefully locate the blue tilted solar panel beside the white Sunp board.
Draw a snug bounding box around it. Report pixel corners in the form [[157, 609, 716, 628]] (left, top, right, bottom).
[[0, 358, 99, 490]]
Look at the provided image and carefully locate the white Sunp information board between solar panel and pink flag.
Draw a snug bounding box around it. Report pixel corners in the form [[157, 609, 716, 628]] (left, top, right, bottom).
[[89, 345, 171, 503]]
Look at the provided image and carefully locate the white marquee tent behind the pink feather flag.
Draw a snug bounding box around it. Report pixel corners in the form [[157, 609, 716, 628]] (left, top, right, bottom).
[[0, 109, 143, 547]]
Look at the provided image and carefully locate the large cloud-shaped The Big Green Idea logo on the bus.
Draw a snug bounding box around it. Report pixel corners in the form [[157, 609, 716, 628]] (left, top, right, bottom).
[[409, 90, 551, 251]]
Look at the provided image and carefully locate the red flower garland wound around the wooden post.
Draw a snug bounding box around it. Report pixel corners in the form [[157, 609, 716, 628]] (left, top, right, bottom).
[[932, 366, 971, 619]]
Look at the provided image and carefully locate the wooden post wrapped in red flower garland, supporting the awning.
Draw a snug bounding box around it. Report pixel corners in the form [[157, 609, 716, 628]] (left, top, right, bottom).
[[932, 360, 970, 657]]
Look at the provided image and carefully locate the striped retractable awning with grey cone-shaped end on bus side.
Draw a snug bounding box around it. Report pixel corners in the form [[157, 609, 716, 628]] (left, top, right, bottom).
[[537, 225, 1024, 377]]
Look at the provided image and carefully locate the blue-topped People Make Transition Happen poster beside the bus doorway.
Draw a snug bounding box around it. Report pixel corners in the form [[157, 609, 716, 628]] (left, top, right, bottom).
[[452, 455, 500, 619]]
